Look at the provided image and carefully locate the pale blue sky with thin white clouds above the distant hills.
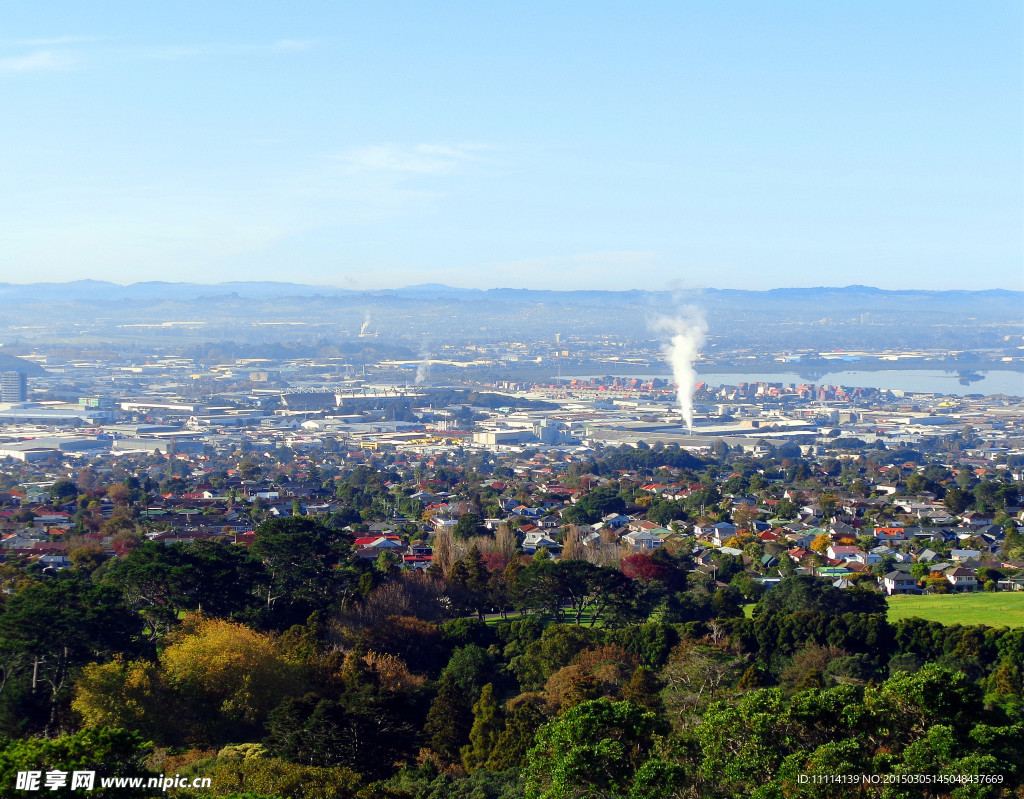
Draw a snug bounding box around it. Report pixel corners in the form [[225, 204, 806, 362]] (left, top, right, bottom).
[[0, 0, 1024, 289]]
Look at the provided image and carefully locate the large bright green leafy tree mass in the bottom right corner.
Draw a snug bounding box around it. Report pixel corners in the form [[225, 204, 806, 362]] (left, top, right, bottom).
[[694, 664, 1003, 799]]
